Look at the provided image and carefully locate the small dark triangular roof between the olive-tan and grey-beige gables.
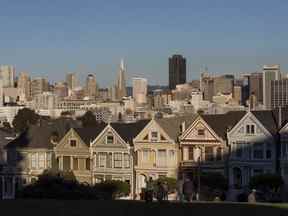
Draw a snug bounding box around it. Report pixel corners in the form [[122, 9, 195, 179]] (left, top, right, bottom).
[[74, 123, 107, 146]]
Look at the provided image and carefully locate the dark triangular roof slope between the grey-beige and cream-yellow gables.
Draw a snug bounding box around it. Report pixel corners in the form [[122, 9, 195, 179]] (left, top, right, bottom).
[[110, 119, 150, 145]]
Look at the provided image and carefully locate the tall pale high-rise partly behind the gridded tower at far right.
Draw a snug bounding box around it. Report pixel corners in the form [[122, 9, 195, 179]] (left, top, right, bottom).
[[263, 65, 280, 109]]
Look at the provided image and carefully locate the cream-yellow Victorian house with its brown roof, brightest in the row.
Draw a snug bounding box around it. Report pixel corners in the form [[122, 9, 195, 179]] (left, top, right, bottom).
[[134, 116, 195, 195]]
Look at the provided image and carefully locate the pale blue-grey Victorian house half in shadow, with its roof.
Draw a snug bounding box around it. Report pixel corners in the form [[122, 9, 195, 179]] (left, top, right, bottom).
[[227, 111, 278, 191]]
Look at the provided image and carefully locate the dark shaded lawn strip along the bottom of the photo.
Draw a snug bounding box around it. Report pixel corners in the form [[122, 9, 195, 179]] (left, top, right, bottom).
[[0, 200, 288, 216]]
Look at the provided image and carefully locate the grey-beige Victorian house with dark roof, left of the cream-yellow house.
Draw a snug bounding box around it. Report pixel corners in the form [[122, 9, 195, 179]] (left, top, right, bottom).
[[90, 120, 149, 195]]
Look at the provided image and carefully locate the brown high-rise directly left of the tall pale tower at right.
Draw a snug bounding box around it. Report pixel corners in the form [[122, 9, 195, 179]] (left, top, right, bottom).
[[248, 73, 263, 104]]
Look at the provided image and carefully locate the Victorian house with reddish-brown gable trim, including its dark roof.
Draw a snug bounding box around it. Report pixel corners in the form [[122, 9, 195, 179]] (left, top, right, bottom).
[[179, 111, 245, 180]]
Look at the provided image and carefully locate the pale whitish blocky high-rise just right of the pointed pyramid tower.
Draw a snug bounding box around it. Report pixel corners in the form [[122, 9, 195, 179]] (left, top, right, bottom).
[[132, 77, 148, 104]]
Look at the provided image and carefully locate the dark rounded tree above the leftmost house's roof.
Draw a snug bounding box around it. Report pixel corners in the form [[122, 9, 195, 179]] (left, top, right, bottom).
[[12, 108, 40, 133]]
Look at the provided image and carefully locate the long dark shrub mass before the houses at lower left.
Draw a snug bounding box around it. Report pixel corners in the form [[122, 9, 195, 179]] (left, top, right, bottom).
[[16, 170, 130, 200]]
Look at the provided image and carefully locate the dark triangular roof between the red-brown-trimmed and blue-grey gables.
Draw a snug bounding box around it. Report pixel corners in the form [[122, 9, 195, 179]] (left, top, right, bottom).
[[201, 111, 246, 140]]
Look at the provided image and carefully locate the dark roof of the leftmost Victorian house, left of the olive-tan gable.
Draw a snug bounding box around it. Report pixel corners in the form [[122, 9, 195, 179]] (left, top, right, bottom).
[[6, 119, 81, 149]]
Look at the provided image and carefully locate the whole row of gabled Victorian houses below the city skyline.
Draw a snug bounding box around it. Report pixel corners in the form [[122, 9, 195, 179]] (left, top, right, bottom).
[[0, 110, 288, 198]]
